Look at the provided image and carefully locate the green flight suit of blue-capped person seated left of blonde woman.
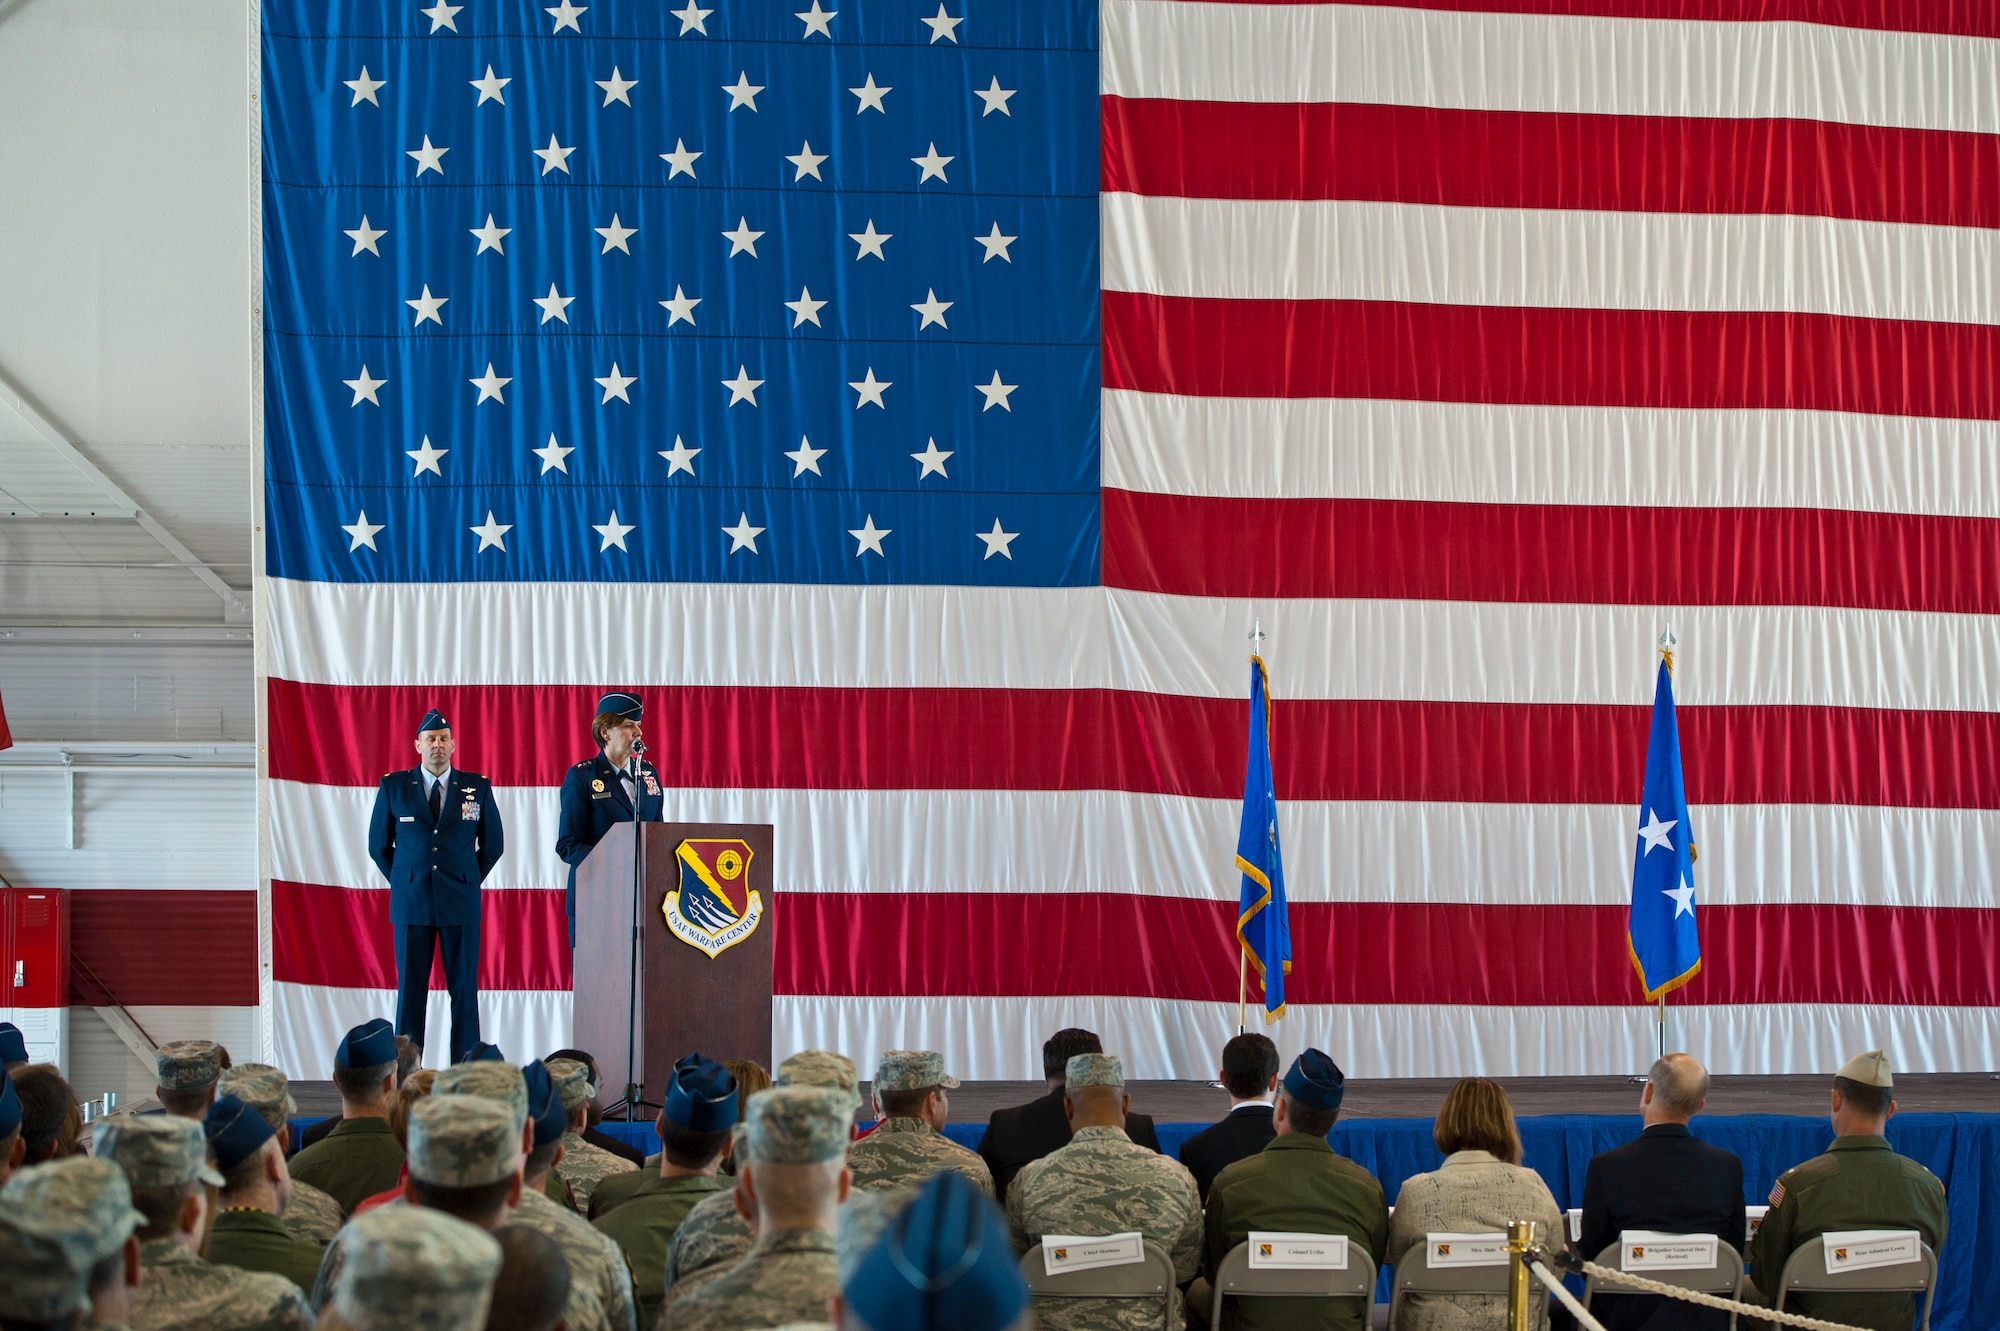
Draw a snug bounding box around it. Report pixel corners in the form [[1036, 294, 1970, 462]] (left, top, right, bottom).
[[1202, 1133, 1388, 1331]]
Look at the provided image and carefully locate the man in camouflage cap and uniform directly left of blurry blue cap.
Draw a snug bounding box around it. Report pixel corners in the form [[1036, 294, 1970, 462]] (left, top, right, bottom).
[[660, 1085, 854, 1331]]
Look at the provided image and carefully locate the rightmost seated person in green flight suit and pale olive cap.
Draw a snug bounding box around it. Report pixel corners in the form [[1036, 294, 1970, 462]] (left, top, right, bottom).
[[1750, 1049, 1946, 1331]]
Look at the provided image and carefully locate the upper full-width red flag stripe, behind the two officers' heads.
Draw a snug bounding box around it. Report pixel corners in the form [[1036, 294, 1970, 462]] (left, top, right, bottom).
[[266, 679, 2000, 809]]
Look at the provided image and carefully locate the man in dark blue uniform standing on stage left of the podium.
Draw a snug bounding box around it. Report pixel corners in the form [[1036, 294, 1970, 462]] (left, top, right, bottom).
[[368, 707, 504, 1061]]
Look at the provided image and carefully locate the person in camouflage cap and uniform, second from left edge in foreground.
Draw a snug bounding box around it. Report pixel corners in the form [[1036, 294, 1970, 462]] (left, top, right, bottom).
[[98, 1113, 312, 1331]]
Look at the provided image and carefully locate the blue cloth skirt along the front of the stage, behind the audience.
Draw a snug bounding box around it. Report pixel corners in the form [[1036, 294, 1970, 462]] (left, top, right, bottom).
[[458, 1113, 2000, 1331]]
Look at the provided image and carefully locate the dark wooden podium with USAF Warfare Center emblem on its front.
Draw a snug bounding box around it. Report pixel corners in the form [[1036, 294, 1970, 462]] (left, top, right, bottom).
[[574, 823, 776, 1103]]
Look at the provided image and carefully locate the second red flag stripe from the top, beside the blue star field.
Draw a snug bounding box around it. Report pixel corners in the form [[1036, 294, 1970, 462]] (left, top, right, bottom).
[[1102, 96, 2000, 228]]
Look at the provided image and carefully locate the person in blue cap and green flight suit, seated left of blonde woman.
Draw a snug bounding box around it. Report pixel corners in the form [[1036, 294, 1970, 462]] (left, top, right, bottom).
[[1190, 1037, 1388, 1331]]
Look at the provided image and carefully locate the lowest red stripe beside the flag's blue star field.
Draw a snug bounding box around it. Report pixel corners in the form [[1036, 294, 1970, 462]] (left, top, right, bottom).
[[1104, 490, 2000, 614]]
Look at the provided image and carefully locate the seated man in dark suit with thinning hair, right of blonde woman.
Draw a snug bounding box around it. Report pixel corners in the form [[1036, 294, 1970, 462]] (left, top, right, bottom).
[[1578, 1053, 1744, 1331]]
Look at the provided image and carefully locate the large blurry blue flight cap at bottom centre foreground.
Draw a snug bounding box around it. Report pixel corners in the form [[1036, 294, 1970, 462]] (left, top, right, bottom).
[[840, 1169, 1028, 1331]]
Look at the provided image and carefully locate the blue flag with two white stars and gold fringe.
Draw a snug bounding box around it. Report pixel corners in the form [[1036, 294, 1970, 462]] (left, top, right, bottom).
[[1626, 662, 1702, 1003]]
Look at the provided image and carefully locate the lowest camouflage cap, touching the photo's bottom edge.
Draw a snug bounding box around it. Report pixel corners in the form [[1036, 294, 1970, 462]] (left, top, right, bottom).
[[334, 1207, 500, 1331]]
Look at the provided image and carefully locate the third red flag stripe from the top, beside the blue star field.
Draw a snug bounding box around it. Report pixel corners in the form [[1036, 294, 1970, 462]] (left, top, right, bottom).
[[1104, 292, 2000, 420]]
